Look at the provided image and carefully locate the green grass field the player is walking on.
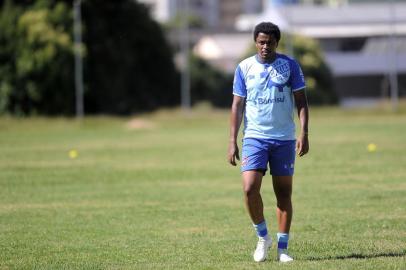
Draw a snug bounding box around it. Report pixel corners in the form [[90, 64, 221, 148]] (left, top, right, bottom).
[[0, 105, 406, 269]]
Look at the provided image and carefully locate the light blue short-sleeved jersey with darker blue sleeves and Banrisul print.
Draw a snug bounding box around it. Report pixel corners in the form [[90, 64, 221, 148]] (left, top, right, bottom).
[[233, 54, 306, 140]]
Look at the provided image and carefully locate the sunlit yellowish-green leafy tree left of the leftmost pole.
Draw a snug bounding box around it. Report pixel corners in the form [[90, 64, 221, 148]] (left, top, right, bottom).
[[0, 1, 74, 115]]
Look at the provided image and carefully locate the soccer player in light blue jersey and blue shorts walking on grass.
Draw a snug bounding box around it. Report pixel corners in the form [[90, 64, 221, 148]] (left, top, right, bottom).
[[228, 22, 309, 262]]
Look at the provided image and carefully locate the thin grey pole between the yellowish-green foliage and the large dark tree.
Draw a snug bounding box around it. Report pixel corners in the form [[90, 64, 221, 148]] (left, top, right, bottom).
[[73, 0, 84, 118]]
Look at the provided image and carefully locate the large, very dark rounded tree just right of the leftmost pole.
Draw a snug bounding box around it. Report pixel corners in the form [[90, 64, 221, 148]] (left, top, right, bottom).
[[83, 0, 180, 114]]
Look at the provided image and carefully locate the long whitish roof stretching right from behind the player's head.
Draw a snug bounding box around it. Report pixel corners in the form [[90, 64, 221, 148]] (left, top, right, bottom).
[[236, 2, 406, 38]]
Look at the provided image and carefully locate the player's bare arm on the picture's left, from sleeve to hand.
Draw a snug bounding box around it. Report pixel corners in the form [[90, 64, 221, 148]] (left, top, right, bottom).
[[228, 96, 244, 166]]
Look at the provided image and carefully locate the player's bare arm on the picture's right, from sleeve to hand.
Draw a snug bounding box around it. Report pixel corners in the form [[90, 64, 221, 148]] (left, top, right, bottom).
[[293, 89, 309, 157]]
